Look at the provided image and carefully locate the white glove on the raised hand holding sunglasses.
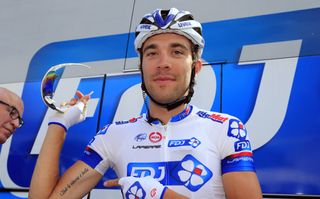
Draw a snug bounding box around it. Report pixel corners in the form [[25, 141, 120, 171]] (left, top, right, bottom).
[[48, 101, 87, 131]]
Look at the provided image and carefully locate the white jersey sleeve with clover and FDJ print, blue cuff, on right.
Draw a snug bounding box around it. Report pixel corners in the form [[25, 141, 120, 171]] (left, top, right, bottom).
[[220, 117, 255, 175]]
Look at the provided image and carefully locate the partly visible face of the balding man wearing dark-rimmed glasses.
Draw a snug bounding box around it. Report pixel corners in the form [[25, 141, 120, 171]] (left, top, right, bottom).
[[0, 93, 23, 144]]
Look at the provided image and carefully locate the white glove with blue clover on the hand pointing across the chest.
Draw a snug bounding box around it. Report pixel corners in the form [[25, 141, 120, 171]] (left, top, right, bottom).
[[119, 176, 167, 199]]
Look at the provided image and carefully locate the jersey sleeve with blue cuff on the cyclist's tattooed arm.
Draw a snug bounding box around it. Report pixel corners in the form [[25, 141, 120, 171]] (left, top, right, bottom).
[[80, 125, 111, 175]]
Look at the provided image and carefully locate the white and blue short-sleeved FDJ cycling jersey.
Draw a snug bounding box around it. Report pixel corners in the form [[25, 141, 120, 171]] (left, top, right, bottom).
[[81, 105, 255, 199]]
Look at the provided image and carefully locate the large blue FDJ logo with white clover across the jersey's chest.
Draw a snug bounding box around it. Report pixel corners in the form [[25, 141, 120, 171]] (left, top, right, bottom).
[[127, 155, 213, 191]]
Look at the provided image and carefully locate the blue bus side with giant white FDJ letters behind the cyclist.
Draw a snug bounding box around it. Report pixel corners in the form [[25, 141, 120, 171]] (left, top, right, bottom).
[[0, 9, 320, 195]]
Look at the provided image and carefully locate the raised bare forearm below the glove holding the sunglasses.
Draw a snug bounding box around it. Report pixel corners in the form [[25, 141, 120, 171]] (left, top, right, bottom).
[[29, 125, 65, 199]]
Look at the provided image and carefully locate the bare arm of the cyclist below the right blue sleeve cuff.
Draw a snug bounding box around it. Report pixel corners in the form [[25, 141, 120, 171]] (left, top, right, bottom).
[[222, 171, 262, 199]]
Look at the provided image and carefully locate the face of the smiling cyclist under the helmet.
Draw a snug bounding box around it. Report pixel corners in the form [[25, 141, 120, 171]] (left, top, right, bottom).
[[141, 33, 193, 103]]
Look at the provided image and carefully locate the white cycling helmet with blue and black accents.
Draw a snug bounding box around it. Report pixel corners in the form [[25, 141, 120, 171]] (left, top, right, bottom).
[[134, 8, 204, 57]]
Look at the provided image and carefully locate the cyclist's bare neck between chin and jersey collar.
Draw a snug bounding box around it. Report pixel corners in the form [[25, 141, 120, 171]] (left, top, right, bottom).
[[149, 100, 186, 124]]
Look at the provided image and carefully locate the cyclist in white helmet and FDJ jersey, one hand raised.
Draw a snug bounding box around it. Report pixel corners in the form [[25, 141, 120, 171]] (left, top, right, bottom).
[[30, 8, 262, 199]]
